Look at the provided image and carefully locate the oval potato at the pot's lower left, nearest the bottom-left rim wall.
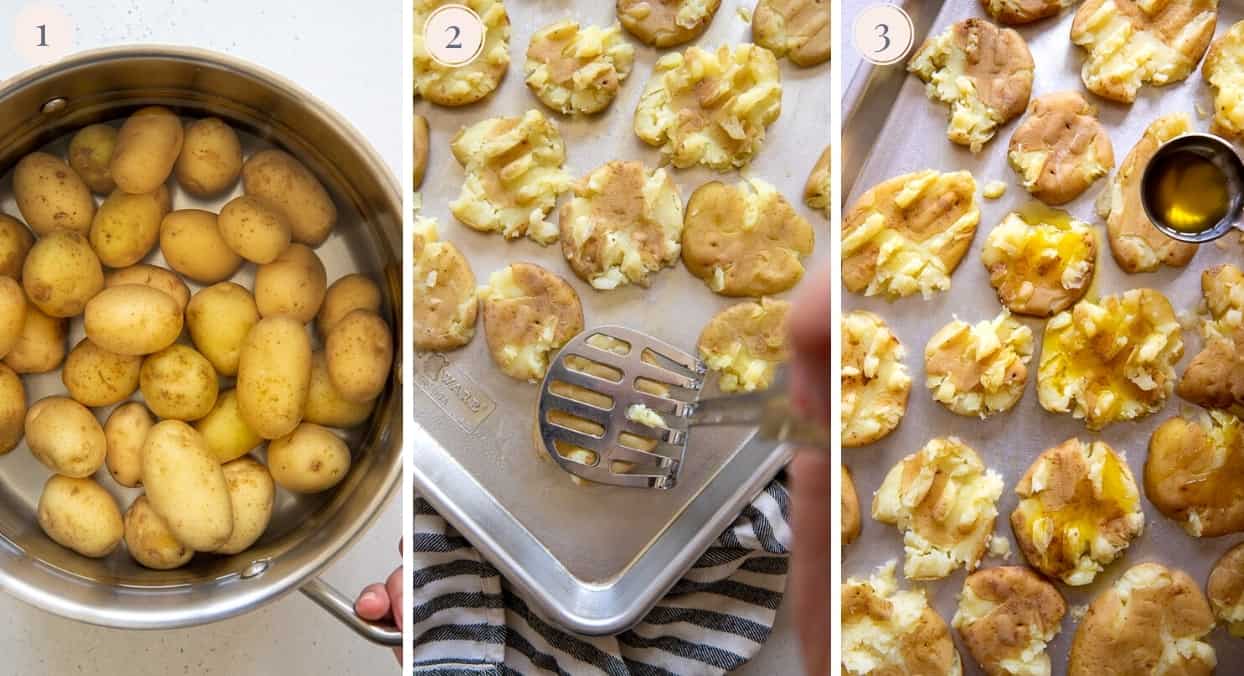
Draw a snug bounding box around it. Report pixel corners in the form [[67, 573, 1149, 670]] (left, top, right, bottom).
[[39, 474, 126, 559]]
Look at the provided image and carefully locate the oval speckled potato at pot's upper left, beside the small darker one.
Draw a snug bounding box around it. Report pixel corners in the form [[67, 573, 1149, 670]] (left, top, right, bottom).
[[12, 153, 95, 237]]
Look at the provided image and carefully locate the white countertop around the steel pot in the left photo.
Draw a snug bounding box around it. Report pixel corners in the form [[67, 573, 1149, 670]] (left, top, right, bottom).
[[0, 0, 404, 676]]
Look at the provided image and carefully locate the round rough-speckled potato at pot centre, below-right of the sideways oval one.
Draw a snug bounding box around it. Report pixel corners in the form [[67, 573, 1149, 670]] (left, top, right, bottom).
[[138, 344, 220, 421]]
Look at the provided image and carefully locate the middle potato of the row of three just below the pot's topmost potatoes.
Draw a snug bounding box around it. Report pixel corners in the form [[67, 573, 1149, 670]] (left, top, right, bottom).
[[159, 209, 241, 284]]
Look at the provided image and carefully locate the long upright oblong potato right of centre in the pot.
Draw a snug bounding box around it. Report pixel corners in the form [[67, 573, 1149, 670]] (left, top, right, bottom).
[[236, 317, 311, 439]]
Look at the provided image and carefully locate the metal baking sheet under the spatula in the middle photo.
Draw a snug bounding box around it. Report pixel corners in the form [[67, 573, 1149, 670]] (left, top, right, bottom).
[[413, 0, 830, 632]]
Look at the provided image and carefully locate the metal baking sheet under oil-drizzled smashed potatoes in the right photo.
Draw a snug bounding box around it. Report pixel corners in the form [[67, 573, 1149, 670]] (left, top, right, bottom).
[[842, 0, 1244, 674]]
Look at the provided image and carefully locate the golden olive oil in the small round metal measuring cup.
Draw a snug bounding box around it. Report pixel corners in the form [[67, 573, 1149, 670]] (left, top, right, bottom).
[[1149, 151, 1230, 233]]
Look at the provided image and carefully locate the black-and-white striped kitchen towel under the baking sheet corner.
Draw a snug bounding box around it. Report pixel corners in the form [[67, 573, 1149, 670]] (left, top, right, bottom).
[[411, 482, 790, 676]]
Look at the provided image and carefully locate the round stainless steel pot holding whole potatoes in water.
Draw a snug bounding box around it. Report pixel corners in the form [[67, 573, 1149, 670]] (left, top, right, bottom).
[[0, 46, 402, 645]]
